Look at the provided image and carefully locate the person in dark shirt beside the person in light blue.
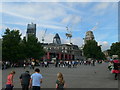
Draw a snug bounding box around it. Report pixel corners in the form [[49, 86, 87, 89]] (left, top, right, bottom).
[[20, 71, 30, 90]]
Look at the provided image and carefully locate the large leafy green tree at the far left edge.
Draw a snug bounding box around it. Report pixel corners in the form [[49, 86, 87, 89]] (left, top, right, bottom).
[[2, 28, 21, 62]]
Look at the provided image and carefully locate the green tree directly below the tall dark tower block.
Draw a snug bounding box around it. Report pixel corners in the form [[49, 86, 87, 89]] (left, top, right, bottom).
[[23, 35, 45, 59]]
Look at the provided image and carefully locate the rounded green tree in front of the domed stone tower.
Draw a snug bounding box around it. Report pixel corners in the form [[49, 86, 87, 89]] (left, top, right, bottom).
[[83, 40, 105, 59]]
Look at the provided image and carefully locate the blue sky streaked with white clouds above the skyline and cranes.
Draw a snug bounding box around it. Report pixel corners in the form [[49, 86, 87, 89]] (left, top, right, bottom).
[[0, 0, 118, 50]]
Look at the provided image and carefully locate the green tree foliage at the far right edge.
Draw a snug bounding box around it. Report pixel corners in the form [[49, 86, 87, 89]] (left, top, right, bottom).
[[109, 42, 120, 58]]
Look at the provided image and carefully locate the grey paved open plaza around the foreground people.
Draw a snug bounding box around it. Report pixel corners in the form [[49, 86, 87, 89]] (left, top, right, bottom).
[[2, 63, 118, 88]]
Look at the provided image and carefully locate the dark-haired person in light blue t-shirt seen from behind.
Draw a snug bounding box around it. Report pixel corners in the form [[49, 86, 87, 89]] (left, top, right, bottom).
[[30, 68, 43, 90]]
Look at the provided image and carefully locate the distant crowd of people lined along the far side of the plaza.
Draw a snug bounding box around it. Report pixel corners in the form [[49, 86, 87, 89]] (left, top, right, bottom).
[[2, 60, 99, 70]]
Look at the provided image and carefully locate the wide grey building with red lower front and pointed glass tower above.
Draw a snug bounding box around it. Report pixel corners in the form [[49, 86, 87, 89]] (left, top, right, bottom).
[[42, 34, 82, 60]]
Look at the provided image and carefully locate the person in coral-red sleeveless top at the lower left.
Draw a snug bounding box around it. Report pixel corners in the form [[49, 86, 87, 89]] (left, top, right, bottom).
[[5, 71, 15, 90]]
